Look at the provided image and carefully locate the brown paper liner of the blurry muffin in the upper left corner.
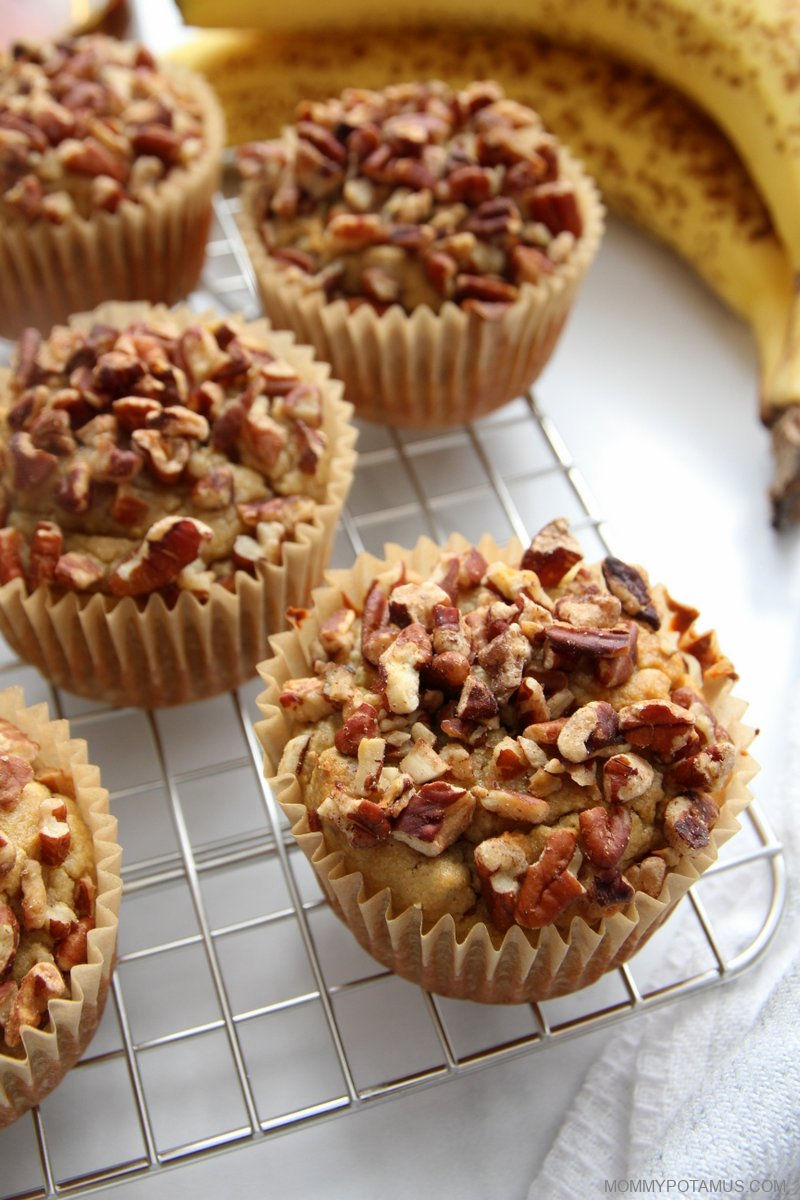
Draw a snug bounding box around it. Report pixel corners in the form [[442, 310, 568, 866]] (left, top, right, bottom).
[[0, 66, 225, 337]]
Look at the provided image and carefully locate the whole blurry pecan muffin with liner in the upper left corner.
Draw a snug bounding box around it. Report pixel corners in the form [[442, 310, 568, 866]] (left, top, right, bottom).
[[0, 34, 224, 336]]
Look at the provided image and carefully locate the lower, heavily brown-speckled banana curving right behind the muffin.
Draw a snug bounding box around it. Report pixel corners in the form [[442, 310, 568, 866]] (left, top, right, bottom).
[[170, 27, 800, 524]]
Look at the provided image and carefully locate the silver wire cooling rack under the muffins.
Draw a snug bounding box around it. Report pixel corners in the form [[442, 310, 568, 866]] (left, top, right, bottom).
[[0, 197, 786, 1200]]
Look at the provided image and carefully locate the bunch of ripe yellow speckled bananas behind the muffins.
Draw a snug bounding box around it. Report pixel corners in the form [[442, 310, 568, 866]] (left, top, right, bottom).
[[173, 9, 800, 526]]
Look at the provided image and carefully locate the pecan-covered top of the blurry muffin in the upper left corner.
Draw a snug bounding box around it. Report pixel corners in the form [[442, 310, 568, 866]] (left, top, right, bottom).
[[0, 34, 206, 224]]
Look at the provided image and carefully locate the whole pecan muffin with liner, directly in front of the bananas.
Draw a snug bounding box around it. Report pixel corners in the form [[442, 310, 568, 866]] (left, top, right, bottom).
[[239, 82, 602, 424]]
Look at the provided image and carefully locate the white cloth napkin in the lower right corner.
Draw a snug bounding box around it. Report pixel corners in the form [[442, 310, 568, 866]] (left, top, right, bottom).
[[529, 710, 800, 1200]]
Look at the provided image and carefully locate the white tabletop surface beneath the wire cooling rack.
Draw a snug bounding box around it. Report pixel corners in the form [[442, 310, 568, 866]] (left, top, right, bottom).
[[0, 211, 800, 1200]]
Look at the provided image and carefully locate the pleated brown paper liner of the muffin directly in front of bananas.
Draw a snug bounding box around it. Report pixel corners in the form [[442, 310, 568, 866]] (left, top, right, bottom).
[[240, 154, 604, 428]]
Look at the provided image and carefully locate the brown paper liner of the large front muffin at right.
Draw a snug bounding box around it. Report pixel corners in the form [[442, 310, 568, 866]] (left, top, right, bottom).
[[257, 534, 758, 1003]]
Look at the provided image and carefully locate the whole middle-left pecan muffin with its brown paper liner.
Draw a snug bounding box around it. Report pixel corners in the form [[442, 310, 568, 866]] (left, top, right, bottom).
[[0, 305, 355, 703]]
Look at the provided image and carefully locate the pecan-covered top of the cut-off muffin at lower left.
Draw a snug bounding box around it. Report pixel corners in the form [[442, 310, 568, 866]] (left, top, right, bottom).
[[0, 720, 97, 1054]]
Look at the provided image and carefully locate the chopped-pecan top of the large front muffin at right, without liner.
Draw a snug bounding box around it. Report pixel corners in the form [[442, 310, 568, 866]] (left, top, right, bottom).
[[279, 520, 739, 942]]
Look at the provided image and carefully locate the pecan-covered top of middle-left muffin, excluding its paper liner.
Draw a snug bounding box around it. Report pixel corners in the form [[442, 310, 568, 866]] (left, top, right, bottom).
[[0, 305, 331, 599]]
